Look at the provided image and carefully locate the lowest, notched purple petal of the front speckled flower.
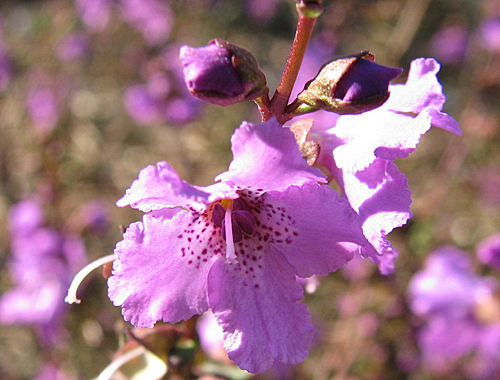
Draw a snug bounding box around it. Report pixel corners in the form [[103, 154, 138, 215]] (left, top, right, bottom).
[[208, 247, 313, 373]]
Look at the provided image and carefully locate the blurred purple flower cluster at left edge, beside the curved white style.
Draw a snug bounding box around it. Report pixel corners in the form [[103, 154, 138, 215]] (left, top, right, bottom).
[[0, 199, 86, 347]]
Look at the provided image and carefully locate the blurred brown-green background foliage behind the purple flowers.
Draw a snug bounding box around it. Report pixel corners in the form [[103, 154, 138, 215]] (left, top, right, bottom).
[[0, 0, 500, 380]]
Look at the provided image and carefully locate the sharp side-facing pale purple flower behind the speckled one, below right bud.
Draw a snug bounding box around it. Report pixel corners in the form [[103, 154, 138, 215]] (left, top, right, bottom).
[[300, 58, 461, 274]]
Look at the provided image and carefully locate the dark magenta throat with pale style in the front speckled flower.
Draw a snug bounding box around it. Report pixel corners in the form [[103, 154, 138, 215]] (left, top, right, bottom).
[[212, 198, 256, 263]]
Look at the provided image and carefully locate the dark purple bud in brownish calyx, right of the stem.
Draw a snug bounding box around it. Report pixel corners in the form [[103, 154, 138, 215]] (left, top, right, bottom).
[[297, 52, 403, 115]]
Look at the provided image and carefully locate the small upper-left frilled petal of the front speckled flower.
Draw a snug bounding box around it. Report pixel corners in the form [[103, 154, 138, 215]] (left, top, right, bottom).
[[116, 162, 236, 212]]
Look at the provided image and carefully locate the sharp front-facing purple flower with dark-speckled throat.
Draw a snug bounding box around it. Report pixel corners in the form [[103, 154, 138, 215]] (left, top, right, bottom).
[[108, 119, 368, 373]]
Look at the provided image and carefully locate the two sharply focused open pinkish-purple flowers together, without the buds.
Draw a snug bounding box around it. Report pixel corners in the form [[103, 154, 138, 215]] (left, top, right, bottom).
[[108, 52, 460, 373]]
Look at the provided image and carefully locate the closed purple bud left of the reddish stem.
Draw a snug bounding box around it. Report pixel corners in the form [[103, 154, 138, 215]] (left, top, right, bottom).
[[180, 39, 269, 106]]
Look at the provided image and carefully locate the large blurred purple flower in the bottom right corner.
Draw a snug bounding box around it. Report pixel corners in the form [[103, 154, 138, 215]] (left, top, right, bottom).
[[408, 247, 500, 379]]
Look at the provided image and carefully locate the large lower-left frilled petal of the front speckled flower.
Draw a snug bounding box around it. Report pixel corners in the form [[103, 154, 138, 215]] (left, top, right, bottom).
[[108, 209, 222, 327]]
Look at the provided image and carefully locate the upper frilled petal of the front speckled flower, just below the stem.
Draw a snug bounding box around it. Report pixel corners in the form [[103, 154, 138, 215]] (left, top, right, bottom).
[[216, 118, 325, 191]]
